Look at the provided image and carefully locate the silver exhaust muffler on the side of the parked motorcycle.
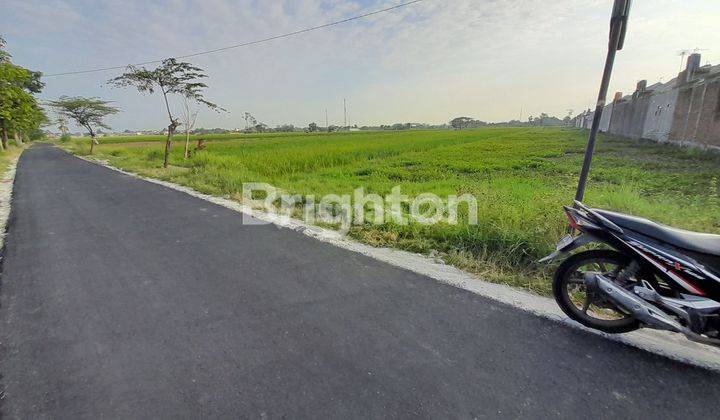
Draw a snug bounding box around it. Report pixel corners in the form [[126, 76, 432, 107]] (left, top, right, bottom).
[[585, 273, 689, 334]]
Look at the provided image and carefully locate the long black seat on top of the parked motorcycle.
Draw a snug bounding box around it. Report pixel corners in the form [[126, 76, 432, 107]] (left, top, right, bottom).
[[593, 209, 720, 256]]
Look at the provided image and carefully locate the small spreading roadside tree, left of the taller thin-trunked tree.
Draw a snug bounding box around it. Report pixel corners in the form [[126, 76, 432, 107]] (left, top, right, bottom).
[[48, 96, 120, 154]]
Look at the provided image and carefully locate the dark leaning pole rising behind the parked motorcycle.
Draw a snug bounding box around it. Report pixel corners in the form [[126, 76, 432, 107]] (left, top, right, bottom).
[[575, 0, 632, 201]]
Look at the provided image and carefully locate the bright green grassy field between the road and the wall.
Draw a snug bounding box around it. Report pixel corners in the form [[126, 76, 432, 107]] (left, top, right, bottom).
[[67, 128, 720, 294]]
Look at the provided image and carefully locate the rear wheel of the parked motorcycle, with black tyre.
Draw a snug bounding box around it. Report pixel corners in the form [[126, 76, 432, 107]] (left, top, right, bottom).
[[553, 249, 640, 334]]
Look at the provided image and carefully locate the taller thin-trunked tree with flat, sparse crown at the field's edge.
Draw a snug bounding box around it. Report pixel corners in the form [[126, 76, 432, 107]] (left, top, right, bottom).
[[108, 58, 223, 168]]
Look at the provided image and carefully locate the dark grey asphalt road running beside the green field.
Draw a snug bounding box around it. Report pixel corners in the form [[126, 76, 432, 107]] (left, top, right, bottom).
[[0, 146, 720, 419]]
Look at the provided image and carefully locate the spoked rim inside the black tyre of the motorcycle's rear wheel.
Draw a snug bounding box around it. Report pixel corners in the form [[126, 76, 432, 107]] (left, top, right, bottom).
[[562, 257, 633, 327]]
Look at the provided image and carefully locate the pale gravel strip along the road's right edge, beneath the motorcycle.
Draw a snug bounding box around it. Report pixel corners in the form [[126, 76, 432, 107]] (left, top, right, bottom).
[[71, 149, 720, 372]]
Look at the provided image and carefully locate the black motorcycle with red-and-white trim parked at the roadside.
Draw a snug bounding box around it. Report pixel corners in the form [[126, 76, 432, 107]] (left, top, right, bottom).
[[540, 201, 720, 346]]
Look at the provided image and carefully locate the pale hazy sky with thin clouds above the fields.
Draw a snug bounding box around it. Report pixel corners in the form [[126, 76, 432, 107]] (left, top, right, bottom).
[[0, 0, 720, 130]]
